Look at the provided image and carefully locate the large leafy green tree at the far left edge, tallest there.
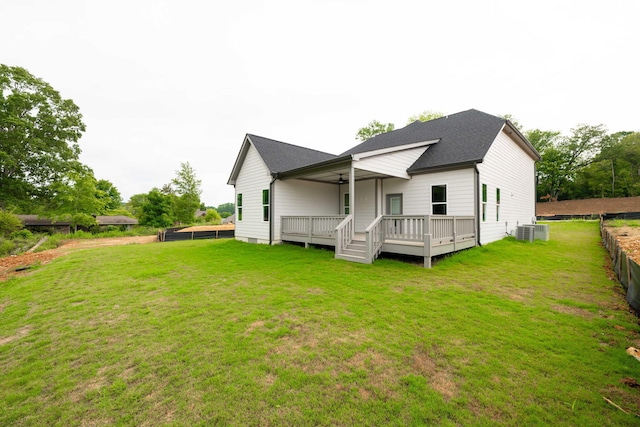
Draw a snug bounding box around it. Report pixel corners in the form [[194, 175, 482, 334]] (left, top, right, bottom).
[[0, 64, 85, 210]]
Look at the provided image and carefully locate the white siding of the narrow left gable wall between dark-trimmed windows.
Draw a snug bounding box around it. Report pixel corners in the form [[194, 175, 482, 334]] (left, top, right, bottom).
[[235, 146, 271, 243]]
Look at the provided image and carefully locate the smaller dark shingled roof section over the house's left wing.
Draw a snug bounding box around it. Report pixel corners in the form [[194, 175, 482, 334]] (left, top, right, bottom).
[[247, 134, 336, 173]]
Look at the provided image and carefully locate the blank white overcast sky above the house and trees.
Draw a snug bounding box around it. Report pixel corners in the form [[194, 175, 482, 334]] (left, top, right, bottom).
[[0, 0, 640, 206]]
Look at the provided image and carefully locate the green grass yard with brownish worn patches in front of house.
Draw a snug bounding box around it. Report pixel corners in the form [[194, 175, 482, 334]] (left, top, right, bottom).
[[0, 222, 640, 426]]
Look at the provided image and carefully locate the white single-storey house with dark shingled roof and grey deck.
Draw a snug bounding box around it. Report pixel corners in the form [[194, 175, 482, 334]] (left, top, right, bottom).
[[228, 110, 540, 266]]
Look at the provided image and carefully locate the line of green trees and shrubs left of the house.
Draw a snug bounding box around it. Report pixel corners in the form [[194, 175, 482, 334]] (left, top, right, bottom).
[[0, 64, 234, 231]]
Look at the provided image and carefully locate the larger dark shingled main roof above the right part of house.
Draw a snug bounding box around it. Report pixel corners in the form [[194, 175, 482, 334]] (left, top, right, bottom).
[[341, 109, 506, 173]]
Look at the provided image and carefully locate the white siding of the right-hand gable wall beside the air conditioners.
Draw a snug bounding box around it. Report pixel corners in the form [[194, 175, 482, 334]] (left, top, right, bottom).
[[477, 132, 535, 244]]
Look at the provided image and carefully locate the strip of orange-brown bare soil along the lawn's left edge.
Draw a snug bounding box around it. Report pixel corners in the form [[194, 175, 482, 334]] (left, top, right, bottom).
[[0, 236, 158, 282]]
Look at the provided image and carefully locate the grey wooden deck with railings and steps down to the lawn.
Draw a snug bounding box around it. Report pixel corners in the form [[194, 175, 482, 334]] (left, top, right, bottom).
[[280, 215, 477, 268]]
